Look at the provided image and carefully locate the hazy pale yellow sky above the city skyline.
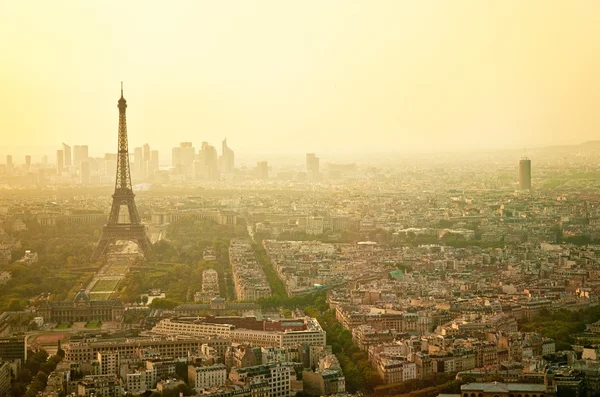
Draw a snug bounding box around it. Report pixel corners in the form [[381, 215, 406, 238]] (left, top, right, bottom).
[[0, 0, 600, 162]]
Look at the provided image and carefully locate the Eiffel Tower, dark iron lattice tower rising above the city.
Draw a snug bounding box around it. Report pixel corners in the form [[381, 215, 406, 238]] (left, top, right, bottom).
[[91, 82, 152, 261]]
